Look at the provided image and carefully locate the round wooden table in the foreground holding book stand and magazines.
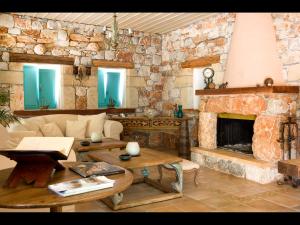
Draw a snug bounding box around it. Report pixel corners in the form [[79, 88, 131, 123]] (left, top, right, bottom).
[[0, 162, 133, 212]]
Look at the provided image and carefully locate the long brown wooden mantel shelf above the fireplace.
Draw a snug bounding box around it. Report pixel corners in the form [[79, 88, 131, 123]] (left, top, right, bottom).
[[195, 86, 299, 95]]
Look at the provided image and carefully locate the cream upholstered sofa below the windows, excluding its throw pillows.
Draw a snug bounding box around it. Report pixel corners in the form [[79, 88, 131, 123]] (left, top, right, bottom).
[[0, 114, 123, 169]]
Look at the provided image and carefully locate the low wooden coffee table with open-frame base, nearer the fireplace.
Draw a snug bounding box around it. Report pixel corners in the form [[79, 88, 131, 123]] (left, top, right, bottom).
[[89, 148, 183, 210]]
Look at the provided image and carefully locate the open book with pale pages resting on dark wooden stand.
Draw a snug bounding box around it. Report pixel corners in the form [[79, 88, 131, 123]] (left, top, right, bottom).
[[0, 137, 74, 159]]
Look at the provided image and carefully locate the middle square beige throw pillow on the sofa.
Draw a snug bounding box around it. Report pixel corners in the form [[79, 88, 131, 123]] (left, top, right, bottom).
[[66, 120, 87, 139]]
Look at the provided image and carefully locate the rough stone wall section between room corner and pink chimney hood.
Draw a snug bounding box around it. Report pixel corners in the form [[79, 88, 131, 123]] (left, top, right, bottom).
[[161, 13, 235, 114]]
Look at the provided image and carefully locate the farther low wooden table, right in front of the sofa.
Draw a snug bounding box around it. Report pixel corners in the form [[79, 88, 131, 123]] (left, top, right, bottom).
[[73, 138, 127, 161]]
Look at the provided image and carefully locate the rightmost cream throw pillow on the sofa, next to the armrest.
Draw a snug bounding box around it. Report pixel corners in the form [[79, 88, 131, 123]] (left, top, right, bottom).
[[78, 113, 106, 138]]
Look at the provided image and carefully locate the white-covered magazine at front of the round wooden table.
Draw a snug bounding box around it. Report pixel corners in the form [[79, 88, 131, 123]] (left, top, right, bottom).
[[48, 176, 115, 197]]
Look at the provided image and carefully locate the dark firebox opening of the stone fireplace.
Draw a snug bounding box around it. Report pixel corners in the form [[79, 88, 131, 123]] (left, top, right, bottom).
[[217, 113, 255, 154]]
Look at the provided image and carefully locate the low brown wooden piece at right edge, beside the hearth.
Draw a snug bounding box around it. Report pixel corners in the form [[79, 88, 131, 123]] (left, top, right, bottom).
[[278, 159, 300, 187]]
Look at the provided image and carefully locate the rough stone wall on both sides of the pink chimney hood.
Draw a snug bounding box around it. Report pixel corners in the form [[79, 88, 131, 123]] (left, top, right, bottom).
[[161, 13, 300, 115]]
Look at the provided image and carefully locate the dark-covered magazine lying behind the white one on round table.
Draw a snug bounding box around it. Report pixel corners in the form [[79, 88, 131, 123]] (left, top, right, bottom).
[[70, 162, 125, 177]]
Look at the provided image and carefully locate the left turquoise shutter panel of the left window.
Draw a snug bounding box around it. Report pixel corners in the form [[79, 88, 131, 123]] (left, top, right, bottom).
[[23, 65, 39, 109]]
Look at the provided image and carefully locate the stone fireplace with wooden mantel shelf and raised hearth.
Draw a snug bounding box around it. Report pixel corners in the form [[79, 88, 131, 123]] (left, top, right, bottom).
[[191, 86, 299, 184]]
